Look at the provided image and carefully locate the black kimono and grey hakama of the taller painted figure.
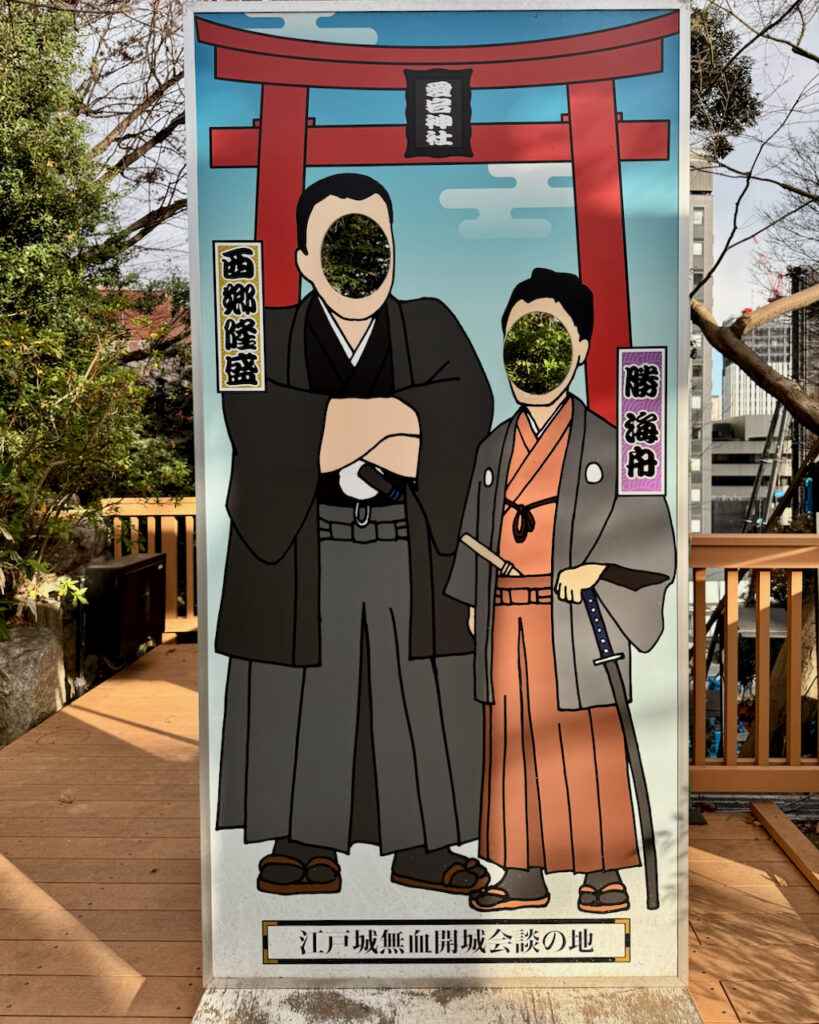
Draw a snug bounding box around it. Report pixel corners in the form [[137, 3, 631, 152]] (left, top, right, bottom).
[[216, 295, 491, 852]]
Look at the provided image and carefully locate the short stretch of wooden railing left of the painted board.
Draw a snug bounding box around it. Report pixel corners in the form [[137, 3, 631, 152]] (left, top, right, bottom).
[[102, 498, 197, 637]]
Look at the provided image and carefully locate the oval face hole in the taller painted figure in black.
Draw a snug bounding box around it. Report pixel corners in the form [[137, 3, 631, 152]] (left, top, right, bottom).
[[321, 213, 390, 299]]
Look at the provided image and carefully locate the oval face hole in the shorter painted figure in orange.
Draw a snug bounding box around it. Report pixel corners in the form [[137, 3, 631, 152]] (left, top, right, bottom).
[[504, 312, 572, 394]]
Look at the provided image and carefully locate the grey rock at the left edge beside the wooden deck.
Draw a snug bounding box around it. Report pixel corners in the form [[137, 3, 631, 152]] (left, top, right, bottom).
[[0, 626, 66, 746]]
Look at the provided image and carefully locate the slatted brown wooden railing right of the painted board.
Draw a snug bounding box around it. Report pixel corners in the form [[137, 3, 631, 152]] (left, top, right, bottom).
[[690, 534, 819, 793]]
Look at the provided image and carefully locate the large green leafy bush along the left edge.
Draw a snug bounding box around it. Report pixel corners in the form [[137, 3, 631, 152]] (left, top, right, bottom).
[[0, 5, 192, 630]]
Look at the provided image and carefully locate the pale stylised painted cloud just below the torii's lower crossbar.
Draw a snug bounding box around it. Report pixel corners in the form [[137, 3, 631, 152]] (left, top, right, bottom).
[[439, 163, 574, 239]]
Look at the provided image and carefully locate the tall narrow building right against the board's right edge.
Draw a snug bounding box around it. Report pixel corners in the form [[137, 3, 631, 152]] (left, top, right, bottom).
[[688, 156, 714, 534]]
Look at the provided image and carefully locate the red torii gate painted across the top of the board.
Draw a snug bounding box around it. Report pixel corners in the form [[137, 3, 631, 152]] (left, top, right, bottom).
[[196, 11, 679, 422]]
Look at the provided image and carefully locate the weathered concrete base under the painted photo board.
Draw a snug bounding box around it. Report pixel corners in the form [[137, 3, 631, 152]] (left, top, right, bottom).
[[191, 986, 702, 1024]]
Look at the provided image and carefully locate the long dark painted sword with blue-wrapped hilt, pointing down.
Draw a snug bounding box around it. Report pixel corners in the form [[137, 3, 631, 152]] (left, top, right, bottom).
[[583, 589, 659, 910]]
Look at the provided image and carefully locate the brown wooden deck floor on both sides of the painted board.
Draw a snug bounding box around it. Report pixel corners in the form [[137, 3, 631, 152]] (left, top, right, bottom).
[[0, 645, 819, 1024]]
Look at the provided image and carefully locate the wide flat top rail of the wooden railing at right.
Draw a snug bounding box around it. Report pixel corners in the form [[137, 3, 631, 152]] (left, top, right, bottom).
[[689, 534, 819, 569]]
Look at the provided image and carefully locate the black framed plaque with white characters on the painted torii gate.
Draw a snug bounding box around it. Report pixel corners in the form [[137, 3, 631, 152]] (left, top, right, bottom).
[[404, 68, 472, 158]]
